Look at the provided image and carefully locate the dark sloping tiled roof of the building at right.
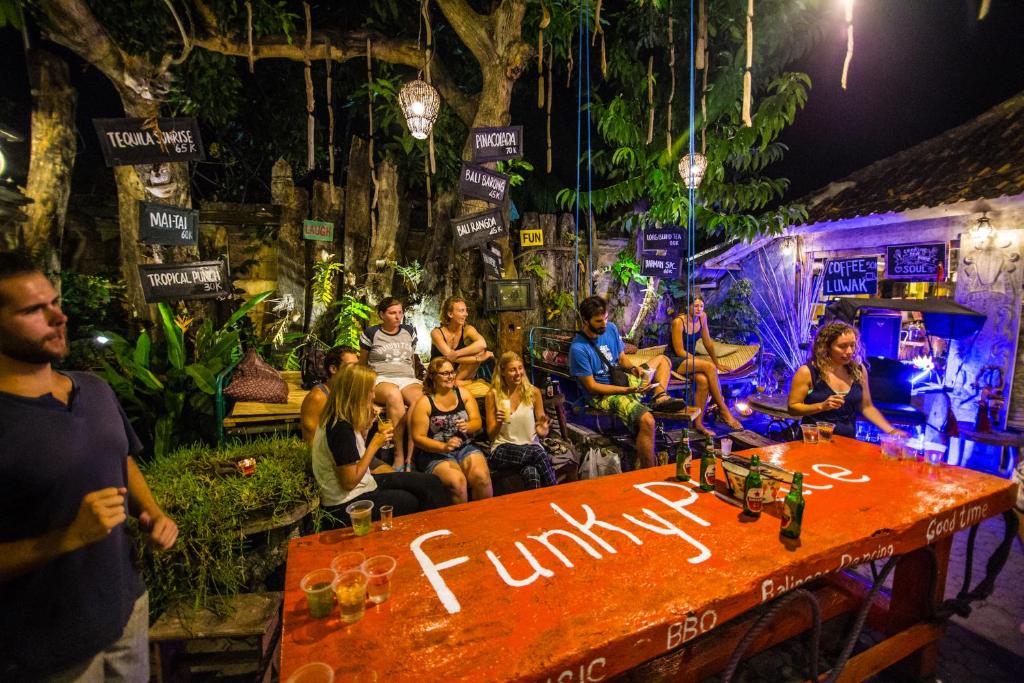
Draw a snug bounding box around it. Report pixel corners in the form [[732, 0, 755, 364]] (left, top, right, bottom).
[[799, 92, 1024, 223]]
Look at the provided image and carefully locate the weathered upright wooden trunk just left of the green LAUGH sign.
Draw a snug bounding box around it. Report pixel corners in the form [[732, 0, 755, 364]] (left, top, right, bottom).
[[270, 159, 309, 325]]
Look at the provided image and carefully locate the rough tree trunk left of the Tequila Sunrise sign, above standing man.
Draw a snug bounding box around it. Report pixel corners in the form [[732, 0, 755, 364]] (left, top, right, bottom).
[[22, 50, 76, 278]]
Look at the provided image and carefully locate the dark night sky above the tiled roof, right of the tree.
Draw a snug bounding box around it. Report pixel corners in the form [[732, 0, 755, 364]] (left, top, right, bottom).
[[774, 0, 1024, 199]]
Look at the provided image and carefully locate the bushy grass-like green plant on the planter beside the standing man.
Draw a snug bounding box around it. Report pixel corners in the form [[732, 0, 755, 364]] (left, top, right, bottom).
[[138, 437, 319, 612]]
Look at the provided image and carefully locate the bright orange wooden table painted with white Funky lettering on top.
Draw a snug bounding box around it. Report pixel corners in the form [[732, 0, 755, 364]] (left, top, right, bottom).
[[281, 437, 1016, 683]]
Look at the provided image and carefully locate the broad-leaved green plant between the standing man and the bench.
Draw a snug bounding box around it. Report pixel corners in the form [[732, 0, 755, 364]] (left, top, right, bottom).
[[96, 292, 270, 456]]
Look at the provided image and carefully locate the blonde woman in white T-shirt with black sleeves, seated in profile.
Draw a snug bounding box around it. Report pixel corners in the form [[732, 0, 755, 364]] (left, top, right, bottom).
[[312, 366, 447, 523]]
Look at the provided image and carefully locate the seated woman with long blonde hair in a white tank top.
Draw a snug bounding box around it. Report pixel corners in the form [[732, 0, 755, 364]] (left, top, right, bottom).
[[485, 351, 557, 488]]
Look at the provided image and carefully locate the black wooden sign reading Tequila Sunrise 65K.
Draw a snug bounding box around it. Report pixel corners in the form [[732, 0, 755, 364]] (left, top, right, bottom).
[[92, 118, 206, 166]]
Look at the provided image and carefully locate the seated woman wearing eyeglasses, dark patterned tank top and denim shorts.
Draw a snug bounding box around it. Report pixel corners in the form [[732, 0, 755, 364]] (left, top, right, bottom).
[[412, 357, 493, 503]]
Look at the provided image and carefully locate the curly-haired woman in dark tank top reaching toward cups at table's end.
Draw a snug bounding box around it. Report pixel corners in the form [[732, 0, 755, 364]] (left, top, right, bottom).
[[790, 322, 904, 437]]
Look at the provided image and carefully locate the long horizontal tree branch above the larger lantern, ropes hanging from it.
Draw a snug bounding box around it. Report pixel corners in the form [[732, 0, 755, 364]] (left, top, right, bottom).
[[193, 28, 479, 126]]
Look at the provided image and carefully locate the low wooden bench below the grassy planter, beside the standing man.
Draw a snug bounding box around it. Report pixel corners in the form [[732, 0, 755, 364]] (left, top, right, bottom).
[[150, 593, 284, 683]]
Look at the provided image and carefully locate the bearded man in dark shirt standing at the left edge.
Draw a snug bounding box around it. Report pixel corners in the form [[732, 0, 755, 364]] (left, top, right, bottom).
[[0, 252, 178, 681]]
